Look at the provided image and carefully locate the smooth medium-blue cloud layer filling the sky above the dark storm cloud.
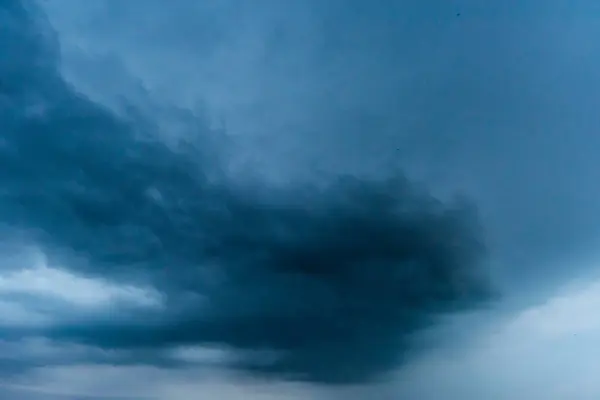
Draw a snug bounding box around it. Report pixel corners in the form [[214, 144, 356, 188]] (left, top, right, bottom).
[[39, 0, 600, 290]]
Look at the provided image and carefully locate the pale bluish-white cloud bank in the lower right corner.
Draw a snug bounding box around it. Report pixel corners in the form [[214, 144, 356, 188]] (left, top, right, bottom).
[[393, 272, 600, 400]]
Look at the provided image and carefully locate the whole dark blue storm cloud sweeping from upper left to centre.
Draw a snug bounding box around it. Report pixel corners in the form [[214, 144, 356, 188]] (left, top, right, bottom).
[[0, 0, 489, 383]]
